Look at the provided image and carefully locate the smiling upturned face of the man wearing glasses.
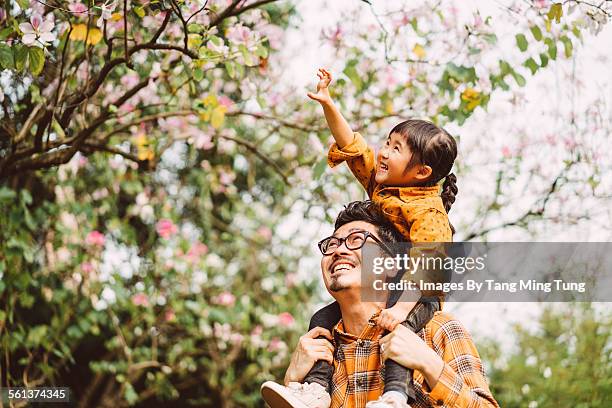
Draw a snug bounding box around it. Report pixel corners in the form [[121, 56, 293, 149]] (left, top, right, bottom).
[[321, 221, 380, 295]]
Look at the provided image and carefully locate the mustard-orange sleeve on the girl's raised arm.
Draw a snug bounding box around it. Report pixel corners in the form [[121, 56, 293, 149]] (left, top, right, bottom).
[[327, 132, 376, 197]]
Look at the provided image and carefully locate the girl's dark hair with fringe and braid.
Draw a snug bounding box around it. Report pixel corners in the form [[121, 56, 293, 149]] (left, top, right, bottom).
[[389, 119, 458, 212]]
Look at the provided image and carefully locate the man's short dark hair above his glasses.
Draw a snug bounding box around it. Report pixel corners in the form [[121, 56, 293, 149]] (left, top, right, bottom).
[[334, 200, 403, 243]]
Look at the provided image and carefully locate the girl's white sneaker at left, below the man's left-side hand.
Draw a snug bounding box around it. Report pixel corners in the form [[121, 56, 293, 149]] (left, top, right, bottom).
[[261, 381, 331, 408]]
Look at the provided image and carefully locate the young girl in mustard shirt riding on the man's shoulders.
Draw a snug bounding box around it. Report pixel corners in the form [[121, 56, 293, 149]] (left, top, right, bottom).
[[260, 69, 457, 408]]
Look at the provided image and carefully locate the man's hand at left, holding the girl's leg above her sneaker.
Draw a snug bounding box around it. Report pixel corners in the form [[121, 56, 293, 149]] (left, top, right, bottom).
[[285, 327, 334, 385]]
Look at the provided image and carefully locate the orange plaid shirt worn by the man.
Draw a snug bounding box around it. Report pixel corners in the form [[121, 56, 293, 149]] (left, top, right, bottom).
[[330, 312, 499, 408]]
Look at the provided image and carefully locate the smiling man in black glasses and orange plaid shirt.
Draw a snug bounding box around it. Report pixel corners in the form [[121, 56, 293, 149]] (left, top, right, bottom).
[[262, 201, 499, 408]]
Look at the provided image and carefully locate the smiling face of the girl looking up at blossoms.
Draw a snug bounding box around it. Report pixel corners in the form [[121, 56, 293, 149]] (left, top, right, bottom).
[[375, 133, 429, 187]]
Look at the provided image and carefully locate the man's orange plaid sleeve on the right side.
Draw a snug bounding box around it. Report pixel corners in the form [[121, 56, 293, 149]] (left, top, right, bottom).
[[428, 315, 499, 408]]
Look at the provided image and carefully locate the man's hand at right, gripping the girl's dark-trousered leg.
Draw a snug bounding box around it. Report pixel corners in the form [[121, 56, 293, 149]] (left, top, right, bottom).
[[379, 325, 444, 389]]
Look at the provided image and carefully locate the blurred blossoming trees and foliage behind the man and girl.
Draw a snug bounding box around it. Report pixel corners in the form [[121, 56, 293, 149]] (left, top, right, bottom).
[[0, 0, 612, 407]]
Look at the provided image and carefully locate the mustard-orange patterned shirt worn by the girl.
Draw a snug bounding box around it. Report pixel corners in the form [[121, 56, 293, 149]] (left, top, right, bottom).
[[327, 133, 452, 242]]
